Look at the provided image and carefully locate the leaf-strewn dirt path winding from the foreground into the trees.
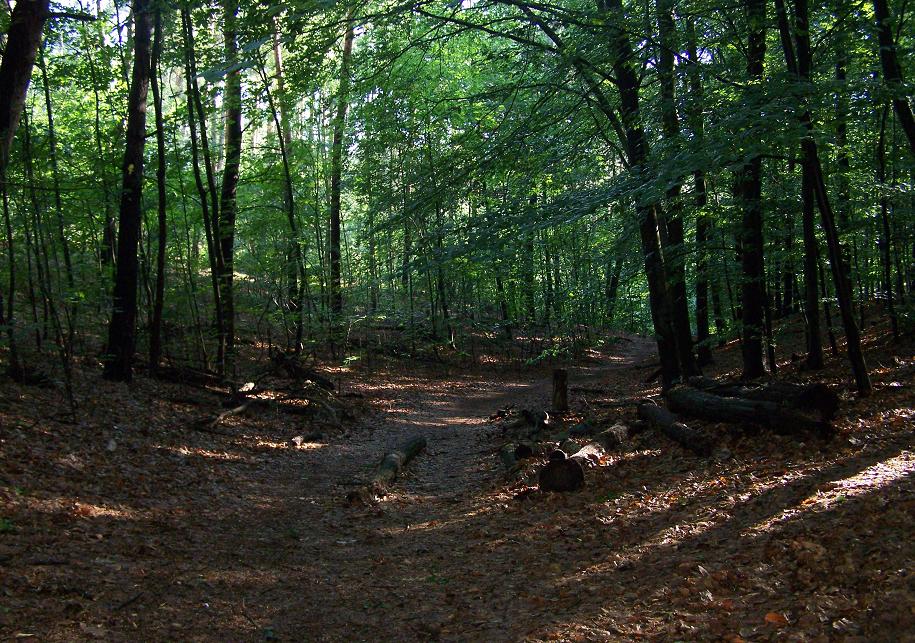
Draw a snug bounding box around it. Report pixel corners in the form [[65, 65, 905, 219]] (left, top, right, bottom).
[[243, 338, 653, 640]]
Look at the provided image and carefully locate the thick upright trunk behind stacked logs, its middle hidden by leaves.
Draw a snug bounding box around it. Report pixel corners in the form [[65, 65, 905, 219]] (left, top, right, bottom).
[[736, 0, 766, 379]]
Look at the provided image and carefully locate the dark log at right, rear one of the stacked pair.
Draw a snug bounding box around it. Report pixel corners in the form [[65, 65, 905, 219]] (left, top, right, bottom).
[[689, 377, 839, 422]]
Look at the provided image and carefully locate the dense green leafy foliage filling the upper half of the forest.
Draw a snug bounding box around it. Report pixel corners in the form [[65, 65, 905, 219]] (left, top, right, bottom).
[[0, 0, 915, 391]]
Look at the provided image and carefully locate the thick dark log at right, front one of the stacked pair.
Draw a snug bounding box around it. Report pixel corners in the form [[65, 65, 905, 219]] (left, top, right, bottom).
[[665, 386, 832, 437]]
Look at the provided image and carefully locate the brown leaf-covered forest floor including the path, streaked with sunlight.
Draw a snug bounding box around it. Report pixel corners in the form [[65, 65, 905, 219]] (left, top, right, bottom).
[[0, 320, 915, 641]]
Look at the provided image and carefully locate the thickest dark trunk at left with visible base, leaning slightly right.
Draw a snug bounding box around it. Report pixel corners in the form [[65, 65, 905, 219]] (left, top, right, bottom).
[[104, 0, 152, 382]]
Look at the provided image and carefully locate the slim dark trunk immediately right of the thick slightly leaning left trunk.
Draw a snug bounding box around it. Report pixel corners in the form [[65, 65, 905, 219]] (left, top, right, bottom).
[[149, 5, 168, 371]]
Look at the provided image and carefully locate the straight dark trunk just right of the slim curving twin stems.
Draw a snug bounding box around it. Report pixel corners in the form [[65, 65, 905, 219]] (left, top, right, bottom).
[[219, 0, 242, 377]]
